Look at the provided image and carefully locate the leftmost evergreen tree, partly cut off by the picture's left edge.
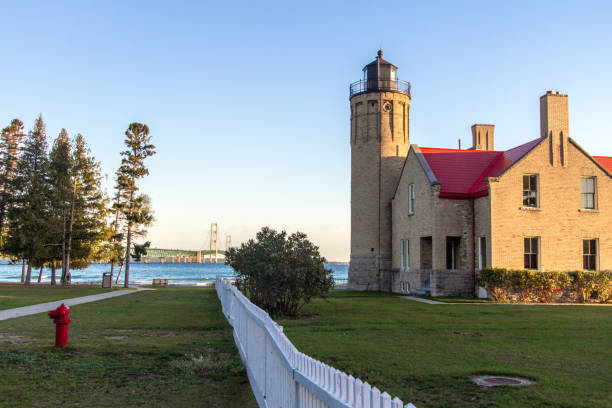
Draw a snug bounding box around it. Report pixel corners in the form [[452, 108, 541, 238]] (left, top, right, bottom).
[[0, 119, 25, 243]]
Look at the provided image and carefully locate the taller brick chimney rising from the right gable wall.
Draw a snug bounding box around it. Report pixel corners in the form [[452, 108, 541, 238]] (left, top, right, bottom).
[[540, 91, 569, 166]]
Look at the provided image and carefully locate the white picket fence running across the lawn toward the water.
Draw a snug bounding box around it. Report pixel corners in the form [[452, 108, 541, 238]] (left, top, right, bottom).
[[216, 277, 415, 408]]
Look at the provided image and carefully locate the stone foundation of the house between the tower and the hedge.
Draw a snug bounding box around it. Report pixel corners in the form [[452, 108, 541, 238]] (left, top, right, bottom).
[[393, 269, 474, 297]]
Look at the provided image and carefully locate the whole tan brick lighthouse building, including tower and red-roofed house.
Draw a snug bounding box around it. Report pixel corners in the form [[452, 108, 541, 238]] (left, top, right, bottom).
[[349, 53, 612, 296]]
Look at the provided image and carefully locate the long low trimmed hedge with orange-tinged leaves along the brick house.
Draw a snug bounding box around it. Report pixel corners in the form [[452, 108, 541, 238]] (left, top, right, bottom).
[[478, 268, 612, 303]]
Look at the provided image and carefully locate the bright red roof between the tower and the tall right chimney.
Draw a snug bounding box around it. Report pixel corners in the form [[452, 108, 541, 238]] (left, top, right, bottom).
[[420, 138, 544, 198]]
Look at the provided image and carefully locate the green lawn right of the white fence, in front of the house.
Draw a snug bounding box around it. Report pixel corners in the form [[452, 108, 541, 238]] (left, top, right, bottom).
[[279, 291, 612, 408]]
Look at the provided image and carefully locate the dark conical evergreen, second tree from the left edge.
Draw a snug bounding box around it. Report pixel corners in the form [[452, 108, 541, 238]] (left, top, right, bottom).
[[5, 116, 50, 285]]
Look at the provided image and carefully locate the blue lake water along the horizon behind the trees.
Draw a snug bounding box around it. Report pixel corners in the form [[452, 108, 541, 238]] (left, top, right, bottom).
[[0, 263, 348, 285]]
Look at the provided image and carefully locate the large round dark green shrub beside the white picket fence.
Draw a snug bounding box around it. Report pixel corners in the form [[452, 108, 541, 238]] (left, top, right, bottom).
[[225, 227, 334, 318]]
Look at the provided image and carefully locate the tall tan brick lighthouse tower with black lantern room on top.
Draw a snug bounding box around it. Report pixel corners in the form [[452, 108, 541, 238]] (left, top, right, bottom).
[[348, 51, 410, 290]]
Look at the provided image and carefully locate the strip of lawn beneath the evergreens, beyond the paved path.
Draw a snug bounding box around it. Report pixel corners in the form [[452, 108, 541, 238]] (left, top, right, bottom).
[[0, 284, 118, 310]]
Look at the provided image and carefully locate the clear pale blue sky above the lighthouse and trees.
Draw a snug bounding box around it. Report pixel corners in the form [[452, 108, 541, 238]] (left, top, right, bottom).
[[0, 1, 612, 260]]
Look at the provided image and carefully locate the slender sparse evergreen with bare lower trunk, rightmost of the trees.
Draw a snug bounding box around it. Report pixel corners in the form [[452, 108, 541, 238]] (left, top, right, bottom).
[[117, 122, 155, 287]]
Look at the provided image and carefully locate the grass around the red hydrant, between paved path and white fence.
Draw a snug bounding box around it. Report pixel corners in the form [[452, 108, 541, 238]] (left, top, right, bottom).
[[0, 287, 256, 408]]
